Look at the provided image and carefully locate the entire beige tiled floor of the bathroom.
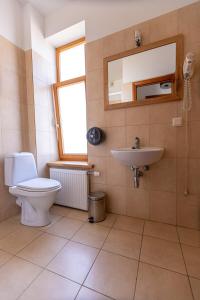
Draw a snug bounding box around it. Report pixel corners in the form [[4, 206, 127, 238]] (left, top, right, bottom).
[[0, 206, 200, 300]]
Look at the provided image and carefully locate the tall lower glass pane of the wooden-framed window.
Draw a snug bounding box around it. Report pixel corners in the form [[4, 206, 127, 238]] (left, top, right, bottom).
[[58, 82, 87, 154]]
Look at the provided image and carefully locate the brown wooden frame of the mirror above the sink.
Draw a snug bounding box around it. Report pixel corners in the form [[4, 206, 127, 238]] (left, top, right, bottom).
[[103, 34, 183, 110]]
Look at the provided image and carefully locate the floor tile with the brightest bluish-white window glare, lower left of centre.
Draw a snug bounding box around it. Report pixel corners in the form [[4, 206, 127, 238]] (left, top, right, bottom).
[[47, 242, 98, 283]]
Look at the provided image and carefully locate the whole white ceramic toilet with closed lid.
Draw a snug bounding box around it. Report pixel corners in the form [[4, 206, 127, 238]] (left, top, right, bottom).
[[4, 152, 61, 226]]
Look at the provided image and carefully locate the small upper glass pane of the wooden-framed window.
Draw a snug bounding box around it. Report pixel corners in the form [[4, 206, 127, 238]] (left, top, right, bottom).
[[60, 44, 85, 81]]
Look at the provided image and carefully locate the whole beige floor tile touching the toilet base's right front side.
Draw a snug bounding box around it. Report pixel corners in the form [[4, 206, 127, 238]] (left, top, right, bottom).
[[47, 218, 83, 239]]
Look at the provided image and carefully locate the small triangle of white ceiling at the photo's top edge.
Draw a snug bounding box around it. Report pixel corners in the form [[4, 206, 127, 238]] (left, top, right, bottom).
[[19, 0, 70, 16]]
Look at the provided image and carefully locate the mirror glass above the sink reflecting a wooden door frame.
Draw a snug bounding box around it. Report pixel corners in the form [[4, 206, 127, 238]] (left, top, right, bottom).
[[108, 42, 176, 104]]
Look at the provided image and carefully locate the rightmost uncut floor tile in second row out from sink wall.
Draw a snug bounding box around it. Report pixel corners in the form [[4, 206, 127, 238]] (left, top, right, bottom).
[[141, 236, 186, 274]]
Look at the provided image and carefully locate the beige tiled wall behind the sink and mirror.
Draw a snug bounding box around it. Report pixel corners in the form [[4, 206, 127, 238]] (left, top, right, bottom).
[[86, 2, 200, 228]]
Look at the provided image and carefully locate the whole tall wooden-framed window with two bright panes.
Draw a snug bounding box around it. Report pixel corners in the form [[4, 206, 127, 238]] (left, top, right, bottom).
[[53, 39, 87, 161]]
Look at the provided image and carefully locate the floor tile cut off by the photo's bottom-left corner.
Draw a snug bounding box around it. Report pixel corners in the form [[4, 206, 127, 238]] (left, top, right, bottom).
[[0, 257, 42, 300]]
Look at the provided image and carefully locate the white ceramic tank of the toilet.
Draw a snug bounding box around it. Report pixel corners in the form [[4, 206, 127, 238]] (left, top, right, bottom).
[[4, 152, 38, 186]]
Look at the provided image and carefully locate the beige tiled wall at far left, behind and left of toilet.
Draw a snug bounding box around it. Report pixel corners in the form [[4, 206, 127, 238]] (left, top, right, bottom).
[[0, 36, 28, 220]]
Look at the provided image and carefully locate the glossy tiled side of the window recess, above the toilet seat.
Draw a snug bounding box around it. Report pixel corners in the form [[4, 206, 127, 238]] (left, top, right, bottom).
[[26, 50, 58, 177]]
